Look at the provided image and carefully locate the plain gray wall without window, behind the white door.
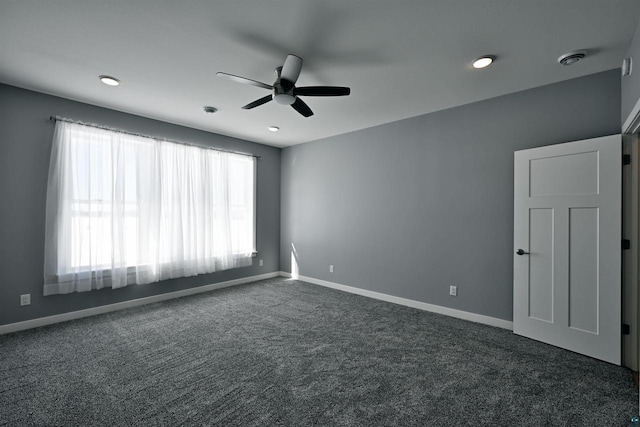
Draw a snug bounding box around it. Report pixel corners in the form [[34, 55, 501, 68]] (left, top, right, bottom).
[[280, 70, 620, 320]]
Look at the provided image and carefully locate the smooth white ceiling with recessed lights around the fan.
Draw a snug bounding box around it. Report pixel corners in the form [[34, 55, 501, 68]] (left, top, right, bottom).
[[0, 0, 640, 147]]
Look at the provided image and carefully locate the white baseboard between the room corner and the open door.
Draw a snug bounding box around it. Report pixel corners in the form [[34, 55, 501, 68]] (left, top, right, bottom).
[[280, 271, 513, 331]]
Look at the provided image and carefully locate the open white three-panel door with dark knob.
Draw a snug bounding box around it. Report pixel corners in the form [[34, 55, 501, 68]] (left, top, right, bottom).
[[513, 135, 622, 365]]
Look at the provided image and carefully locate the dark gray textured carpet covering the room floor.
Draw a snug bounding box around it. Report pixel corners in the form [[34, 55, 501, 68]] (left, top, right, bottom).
[[0, 279, 638, 427]]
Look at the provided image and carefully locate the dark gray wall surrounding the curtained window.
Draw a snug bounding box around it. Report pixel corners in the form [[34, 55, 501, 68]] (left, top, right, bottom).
[[0, 85, 280, 325]]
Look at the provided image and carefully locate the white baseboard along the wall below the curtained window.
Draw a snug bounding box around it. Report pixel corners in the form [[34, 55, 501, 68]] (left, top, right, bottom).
[[0, 271, 282, 335]]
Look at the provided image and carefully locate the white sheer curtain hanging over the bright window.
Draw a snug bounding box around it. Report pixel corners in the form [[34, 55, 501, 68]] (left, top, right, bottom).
[[44, 121, 255, 295]]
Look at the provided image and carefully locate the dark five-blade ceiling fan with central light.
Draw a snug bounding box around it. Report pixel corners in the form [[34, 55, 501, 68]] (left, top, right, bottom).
[[216, 55, 351, 117]]
